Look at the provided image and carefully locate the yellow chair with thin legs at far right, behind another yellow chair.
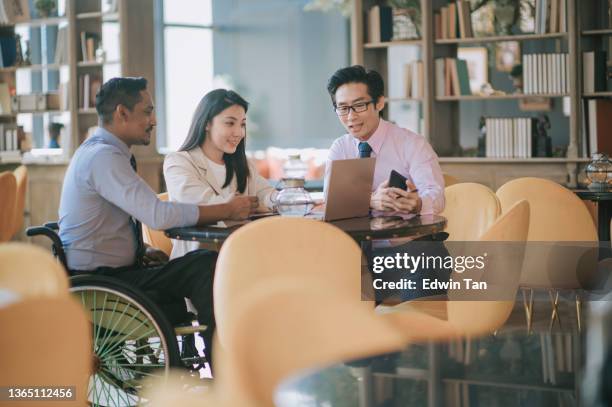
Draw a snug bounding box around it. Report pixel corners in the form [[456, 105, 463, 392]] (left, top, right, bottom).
[[496, 177, 602, 330]]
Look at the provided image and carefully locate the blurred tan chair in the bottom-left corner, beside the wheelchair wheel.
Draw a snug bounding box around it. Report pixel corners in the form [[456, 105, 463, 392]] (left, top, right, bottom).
[[0, 297, 93, 406]]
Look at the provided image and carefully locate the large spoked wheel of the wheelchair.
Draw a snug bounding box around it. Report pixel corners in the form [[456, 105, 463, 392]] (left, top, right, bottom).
[[70, 275, 180, 406]]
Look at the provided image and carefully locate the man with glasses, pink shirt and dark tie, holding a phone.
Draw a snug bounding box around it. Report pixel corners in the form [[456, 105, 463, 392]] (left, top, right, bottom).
[[325, 65, 444, 215]]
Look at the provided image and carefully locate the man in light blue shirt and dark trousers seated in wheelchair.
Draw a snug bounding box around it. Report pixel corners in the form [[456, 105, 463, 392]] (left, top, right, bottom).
[[59, 78, 257, 370]]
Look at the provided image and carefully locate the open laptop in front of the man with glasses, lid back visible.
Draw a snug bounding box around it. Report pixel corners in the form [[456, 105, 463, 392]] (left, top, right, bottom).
[[315, 157, 376, 221]]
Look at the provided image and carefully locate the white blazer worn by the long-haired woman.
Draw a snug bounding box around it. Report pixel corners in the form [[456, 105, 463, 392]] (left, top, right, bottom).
[[164, 148, 275, 259]]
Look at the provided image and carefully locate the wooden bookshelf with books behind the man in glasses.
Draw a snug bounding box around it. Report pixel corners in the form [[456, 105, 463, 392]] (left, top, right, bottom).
[[351, 0, 588, 188]]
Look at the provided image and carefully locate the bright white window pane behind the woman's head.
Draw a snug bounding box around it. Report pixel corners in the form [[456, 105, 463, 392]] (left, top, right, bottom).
[[155, 0, 213, 151]]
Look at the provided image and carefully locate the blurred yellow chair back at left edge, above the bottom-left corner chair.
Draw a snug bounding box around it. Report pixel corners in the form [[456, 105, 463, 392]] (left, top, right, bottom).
[[0, 242, 69, 298]]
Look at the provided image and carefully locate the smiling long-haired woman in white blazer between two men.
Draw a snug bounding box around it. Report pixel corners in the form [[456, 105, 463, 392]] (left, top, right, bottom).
[[164, 89, 275, 258]]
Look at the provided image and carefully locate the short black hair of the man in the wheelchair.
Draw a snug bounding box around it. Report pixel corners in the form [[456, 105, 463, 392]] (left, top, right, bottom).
[[96, 78, 147, 124]]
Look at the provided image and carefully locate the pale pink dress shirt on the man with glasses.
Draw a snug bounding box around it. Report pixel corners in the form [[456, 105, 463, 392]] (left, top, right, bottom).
[[325, 119, 444, 215]]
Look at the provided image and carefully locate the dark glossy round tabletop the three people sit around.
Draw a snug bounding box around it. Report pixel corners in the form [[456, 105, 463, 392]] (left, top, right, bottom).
[[165, 215, 446, 244]]
